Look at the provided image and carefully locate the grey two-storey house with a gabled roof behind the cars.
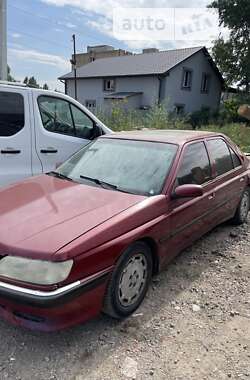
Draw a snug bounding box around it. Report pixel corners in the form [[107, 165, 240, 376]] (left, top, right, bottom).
[[59, 47, 223, 114]]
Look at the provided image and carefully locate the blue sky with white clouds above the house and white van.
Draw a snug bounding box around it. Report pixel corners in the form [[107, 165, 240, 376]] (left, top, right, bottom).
[[7, 0, 223, 90]]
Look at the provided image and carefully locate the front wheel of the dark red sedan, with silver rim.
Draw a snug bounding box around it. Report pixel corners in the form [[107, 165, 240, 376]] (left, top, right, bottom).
[[103, 242, 153, 319]]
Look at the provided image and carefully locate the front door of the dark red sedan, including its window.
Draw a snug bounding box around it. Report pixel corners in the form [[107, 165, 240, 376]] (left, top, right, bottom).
[[166, 141, 217, 256]]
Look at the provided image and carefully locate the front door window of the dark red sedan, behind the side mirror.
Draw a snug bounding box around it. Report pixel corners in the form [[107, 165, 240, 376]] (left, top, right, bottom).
[[175, 142, 211, 186]]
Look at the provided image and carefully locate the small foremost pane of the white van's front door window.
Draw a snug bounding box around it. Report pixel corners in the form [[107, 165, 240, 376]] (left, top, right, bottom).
[[70, 104, 94, 139]]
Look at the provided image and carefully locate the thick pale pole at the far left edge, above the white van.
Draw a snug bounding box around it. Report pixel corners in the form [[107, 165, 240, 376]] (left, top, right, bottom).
[[0, 0, 8, 80]]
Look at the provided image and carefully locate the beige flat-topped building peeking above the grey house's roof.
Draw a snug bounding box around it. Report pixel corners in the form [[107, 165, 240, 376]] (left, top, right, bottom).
[[72, 45, 132, 70]]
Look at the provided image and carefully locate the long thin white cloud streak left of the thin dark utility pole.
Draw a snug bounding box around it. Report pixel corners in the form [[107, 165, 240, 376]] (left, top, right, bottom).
[[9, 48, 70, 70]]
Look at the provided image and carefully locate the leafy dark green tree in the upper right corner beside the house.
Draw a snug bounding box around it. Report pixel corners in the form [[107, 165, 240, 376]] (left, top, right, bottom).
[[209, 0, 250, 93]]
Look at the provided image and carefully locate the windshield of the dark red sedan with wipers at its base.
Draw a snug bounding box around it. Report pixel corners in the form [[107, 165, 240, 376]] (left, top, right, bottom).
[[53, 138, 177, 196]]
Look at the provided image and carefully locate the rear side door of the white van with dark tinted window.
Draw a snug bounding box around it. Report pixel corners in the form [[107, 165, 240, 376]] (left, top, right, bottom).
[[0, 86, 32, 185]]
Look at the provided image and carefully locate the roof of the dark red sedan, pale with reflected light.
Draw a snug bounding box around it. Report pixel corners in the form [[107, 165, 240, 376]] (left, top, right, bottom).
[[102, 129, 223, 145]]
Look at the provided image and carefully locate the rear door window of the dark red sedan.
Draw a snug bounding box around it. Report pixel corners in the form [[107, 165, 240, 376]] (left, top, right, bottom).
[[207, 139, 233, 176]]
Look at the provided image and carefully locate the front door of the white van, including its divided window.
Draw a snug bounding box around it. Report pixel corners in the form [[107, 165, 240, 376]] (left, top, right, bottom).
[[34, 94, 96, 172]]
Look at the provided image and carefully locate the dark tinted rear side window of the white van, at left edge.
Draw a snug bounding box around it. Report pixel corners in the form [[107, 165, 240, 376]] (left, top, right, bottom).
[[0, 91, 25, 137]]
